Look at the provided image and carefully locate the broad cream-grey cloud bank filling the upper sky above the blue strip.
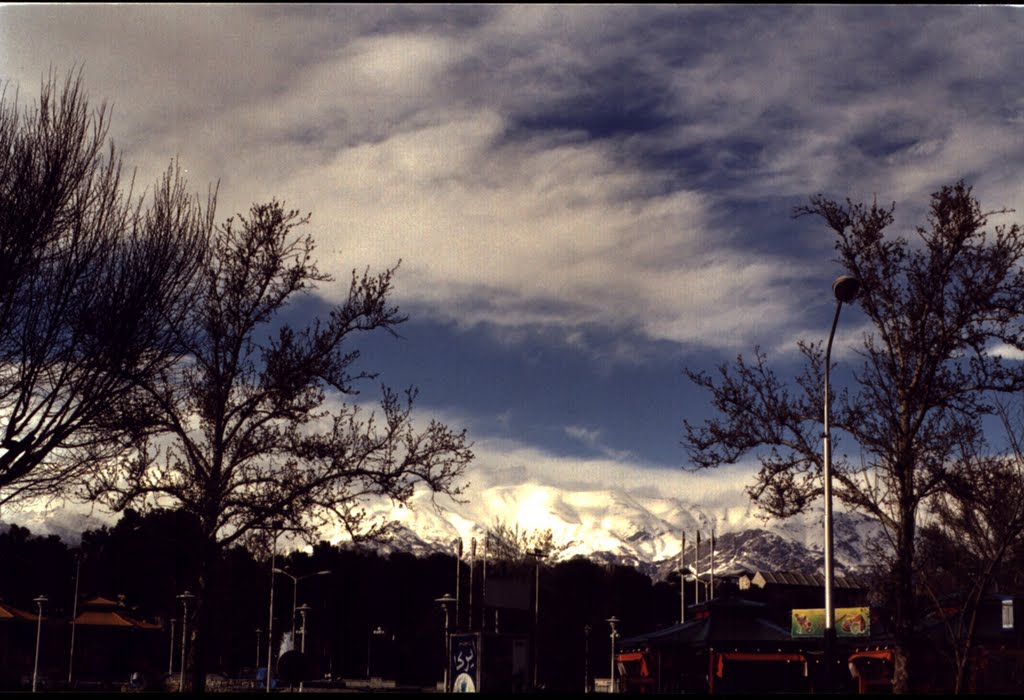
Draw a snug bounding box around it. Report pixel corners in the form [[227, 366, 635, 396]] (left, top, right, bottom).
[[6, 5, 1024, 360]]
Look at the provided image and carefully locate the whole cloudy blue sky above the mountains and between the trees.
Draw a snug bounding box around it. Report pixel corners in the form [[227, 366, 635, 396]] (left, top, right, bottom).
[[0, 3, 1024, 532]]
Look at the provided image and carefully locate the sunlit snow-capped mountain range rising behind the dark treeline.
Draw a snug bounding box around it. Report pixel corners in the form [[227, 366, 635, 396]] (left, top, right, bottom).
[[325, 472, 878, 579]]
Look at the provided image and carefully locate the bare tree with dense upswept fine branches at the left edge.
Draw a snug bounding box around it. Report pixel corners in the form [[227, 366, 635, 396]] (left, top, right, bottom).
[[0, 75, 212, 505]]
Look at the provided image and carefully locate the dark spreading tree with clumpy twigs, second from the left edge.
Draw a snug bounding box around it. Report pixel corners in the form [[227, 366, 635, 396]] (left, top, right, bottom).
[[90, 202, 472, 690]]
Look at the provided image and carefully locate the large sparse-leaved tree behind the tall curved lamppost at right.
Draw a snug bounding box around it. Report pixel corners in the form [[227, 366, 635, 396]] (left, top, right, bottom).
[[683, 182, 1024, 692]]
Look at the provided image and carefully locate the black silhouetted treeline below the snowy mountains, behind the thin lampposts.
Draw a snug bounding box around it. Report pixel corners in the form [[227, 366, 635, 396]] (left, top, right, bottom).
[[0, 511, 679, 691]]
